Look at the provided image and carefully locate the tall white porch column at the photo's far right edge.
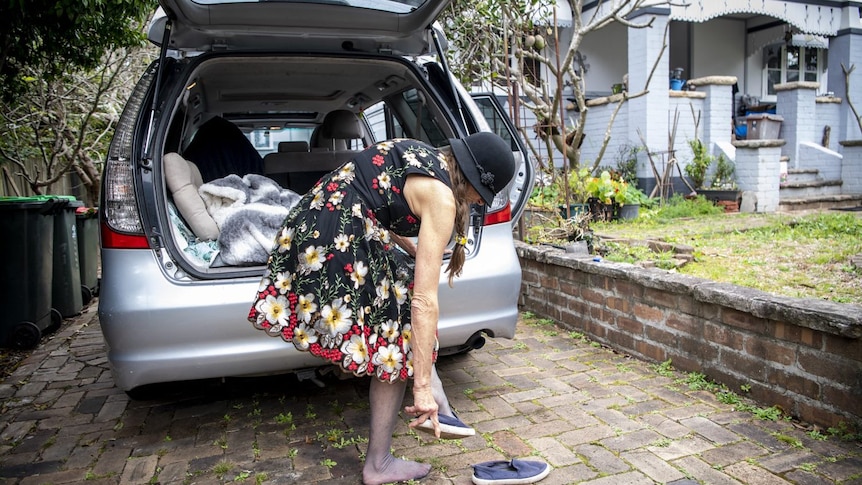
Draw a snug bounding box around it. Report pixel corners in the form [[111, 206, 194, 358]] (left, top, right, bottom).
[[827, 5, 862, 141]]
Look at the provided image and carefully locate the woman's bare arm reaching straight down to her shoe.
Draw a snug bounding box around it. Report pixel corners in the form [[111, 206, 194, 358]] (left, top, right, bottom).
[[404, 175, 455, 436]]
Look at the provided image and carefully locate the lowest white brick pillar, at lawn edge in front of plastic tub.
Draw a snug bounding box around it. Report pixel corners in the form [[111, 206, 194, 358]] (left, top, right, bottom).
[[733, 140, 784, 212]]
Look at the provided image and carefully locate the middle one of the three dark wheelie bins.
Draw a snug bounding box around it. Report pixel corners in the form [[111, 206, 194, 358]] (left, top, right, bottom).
[[51, 195, 84, 317]]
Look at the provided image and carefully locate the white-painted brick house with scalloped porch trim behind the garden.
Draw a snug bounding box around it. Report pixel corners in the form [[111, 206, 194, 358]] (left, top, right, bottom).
[[502, 0, 862, 211]]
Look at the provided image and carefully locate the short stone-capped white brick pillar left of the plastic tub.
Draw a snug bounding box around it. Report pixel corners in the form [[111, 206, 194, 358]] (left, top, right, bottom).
[[687, 76, 736, 154]]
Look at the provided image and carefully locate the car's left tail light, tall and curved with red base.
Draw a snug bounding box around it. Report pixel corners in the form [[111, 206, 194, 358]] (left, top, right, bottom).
[[101, 63, 158, 249]]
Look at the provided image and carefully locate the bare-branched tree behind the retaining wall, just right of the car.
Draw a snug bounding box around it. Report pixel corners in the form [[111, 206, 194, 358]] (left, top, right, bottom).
[[446, 0, 682, 212]]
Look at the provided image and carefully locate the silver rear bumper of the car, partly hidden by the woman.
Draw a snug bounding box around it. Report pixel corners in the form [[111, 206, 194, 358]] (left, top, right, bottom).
[[99, 224, 521, 390]]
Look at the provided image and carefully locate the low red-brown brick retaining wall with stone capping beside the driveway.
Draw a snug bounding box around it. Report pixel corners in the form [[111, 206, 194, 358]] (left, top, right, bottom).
[[515, 241, 862, 427]]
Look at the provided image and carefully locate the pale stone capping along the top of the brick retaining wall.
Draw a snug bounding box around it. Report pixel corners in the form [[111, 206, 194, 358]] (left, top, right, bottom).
[[515, 241, 862, 339]]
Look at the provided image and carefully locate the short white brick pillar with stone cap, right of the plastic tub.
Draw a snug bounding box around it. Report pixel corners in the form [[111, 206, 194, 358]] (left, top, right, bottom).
[[775, 81, 820, 168]]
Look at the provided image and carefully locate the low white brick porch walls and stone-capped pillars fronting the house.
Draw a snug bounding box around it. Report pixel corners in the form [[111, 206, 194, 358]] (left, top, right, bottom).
[[581, 76, 862, 212]]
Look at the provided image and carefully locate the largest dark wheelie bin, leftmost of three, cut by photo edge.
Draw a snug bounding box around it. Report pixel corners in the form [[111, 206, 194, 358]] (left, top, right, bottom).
[[0, 196, 63, 349]]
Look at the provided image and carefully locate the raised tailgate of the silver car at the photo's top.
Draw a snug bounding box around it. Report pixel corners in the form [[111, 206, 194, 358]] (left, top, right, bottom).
[[157, 0, 450, 55]]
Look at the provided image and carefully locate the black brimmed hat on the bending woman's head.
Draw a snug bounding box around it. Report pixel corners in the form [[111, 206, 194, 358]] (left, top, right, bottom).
[[449, 131, 515, 205]]
